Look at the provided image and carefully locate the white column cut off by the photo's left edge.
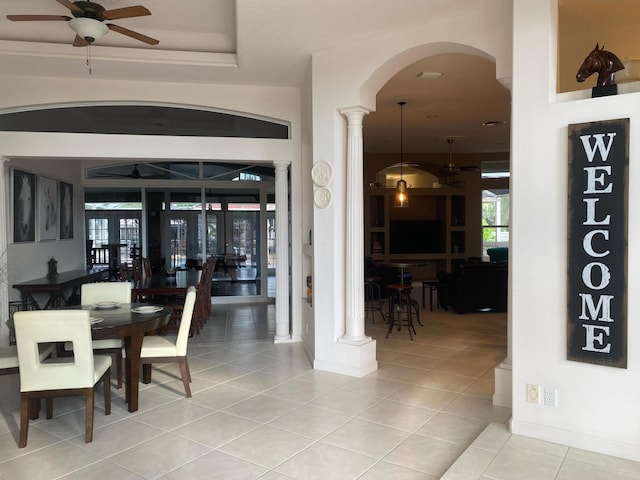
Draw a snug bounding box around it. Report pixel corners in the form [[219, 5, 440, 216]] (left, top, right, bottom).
[[0, 157, 11, 347]]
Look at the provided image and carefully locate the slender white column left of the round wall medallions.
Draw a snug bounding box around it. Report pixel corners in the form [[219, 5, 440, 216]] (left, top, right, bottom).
[[276, 162, 291, 343]]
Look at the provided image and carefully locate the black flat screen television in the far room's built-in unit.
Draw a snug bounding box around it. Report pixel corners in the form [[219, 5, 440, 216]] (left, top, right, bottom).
[[389, 220, 445, 254]]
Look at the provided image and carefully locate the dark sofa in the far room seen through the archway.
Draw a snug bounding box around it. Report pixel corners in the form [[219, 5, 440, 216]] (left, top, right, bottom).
[[438, 262, 509, 313]]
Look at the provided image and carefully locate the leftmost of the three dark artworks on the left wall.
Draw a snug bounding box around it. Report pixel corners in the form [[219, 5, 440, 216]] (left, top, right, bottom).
[[13, 170, 36, 242]]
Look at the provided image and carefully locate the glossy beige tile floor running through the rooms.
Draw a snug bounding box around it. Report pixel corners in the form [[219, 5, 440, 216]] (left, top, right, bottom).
[[0, 305, 640, 480]]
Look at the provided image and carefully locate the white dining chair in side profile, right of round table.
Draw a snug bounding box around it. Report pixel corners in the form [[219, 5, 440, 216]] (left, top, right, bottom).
[[140, 286, 196, 397]]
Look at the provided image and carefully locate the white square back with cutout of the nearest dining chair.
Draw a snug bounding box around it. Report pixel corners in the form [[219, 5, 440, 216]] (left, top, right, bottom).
[[14, 310, 97, 392]]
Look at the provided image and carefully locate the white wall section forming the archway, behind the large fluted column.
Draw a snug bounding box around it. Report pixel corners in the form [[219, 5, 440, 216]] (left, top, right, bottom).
[[312, 0, 511, 375]]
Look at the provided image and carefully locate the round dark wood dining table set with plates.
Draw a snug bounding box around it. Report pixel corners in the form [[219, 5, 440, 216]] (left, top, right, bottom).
[[81, 303, 173, 412]]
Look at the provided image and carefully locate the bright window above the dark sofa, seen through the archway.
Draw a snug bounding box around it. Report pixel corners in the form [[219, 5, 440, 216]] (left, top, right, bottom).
[[482, 189, 509, 258]]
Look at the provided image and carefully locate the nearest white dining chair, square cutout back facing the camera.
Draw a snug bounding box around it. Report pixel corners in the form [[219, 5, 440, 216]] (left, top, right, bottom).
[[14, 310, 111, 448]]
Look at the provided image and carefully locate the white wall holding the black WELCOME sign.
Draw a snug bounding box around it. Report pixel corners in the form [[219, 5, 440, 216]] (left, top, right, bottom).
[[510, 0, 640, 461]]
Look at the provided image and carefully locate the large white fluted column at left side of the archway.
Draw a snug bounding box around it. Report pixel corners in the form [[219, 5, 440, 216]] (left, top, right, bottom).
[[339, 107, 371, 345]]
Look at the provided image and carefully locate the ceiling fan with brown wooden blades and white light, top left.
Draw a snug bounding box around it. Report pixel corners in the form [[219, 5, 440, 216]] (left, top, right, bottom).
[[7, 0, 160, 47]]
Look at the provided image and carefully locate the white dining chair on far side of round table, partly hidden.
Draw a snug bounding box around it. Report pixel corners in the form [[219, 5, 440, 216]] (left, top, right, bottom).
[[72, 282, 131, 389]]
